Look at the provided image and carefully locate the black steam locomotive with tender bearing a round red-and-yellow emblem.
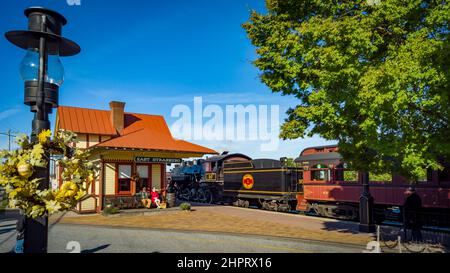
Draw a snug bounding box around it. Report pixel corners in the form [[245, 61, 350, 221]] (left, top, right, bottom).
[[171, 152, 302, 208]]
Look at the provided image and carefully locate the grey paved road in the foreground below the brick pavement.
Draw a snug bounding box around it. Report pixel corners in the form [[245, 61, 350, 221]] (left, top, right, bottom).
[[0, 221, 363, 253]]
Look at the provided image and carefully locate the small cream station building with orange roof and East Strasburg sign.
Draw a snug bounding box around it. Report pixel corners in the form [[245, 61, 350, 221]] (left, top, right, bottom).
[[55, 101, 217, 213]]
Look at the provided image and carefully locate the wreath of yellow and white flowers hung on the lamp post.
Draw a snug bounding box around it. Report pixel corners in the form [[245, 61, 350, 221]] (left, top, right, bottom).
[[0, 130, 97, 218]]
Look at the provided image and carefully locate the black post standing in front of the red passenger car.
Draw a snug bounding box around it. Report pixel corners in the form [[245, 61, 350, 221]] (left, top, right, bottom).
[[359, 172, 375, 232]]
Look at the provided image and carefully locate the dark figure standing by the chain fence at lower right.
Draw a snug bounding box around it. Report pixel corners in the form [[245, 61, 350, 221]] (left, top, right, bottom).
[[403, 187, 422, 242]]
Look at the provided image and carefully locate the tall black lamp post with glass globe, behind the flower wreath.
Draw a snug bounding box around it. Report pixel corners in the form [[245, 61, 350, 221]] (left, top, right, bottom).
[[5, 7, 81, 253]]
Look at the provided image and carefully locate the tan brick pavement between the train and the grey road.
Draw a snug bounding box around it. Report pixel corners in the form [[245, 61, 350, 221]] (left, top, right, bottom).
[[51, 202, 373, 245]]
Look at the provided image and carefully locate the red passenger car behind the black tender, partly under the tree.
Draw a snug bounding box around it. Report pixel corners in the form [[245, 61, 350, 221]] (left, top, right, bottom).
[[296, 146, 450, 226]]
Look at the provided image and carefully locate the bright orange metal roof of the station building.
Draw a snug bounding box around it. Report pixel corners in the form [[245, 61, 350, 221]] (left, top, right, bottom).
[[56, 106, 217, 154]]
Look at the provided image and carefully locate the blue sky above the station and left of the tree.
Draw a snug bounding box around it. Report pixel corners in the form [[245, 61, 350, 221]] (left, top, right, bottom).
[[0, 0, 329, 158]]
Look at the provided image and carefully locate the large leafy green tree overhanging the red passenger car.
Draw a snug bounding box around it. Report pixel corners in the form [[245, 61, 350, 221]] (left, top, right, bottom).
[[243, 0, 450, 181]]
